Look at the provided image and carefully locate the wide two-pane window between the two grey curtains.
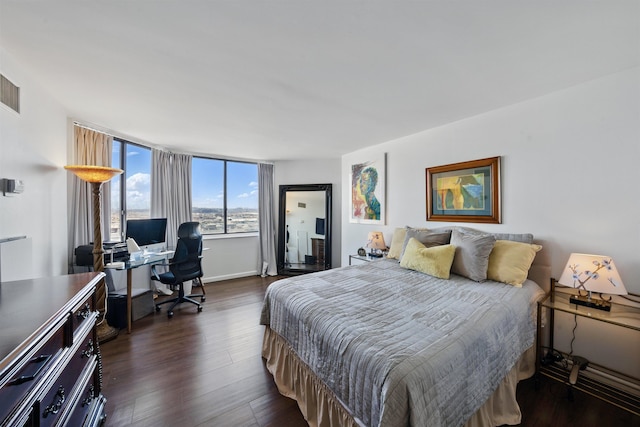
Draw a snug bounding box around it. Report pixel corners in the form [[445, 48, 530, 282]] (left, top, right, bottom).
[[191, 157, 258, 234]]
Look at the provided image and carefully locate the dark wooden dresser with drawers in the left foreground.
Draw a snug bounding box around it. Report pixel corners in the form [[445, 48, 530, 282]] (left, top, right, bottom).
[[0, 273, 106, 427]]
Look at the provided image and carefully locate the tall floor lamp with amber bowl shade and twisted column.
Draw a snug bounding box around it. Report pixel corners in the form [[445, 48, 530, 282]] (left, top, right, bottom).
[[64, 165, 124, 343]]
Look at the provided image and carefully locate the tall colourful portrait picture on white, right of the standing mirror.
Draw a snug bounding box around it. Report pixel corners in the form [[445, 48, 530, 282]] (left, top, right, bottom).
[[349, 153, 386, 225]]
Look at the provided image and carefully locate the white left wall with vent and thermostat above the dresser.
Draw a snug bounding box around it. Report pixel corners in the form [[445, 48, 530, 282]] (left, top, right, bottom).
[[0, 48, 68, 281]]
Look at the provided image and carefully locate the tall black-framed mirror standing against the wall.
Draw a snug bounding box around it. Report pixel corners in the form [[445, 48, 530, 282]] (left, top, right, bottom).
[[278, 184, 331, 275]]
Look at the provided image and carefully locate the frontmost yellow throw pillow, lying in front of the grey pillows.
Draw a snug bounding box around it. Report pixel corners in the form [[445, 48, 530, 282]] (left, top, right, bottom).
[[400, 237, 456, 279]]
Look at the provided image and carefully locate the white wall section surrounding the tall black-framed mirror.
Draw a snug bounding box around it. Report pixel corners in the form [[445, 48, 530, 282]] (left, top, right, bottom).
[[274, 158, 342, 268]]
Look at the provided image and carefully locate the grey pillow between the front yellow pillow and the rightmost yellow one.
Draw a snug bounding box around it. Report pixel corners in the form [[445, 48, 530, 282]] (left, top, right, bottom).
[[451, 229, 496, 282]]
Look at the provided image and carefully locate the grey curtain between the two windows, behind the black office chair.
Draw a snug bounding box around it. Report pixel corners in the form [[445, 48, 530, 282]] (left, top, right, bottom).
[[151, 148, 191, 248]]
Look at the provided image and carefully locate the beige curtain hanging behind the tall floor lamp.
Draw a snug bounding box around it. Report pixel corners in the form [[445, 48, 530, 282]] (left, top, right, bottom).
[[67, 125, 113, 273]]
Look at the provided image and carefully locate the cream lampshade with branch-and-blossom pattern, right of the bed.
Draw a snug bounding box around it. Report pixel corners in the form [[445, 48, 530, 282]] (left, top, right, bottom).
[[558, 254, 627, 295]]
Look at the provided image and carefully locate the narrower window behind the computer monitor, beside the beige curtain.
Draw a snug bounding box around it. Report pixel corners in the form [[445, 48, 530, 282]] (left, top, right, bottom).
[[110, 138, 151, 242]]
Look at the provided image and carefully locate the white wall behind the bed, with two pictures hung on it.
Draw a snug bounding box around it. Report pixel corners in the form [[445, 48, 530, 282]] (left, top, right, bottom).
[[342, 68, 640, 377]]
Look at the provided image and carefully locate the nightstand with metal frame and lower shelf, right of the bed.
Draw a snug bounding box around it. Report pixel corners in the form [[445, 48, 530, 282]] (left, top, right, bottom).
[[536, 279, 640, 415]]
